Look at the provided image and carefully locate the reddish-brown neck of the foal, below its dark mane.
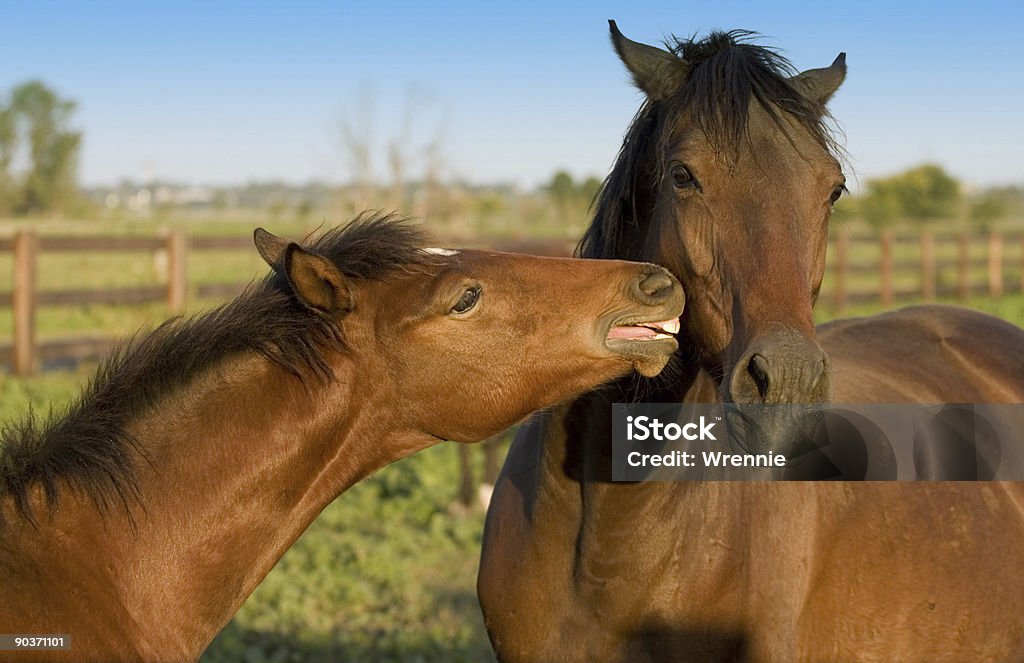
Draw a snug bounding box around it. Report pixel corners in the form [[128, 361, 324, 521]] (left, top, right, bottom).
[[19, 357, 428, 658]]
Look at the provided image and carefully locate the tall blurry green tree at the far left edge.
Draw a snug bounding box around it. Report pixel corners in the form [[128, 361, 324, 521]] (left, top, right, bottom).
[[0, 81, 82, 214]]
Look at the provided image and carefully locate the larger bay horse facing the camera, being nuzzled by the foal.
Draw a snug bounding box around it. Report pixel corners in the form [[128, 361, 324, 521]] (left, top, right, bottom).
[[477, 24, 1024, 663]]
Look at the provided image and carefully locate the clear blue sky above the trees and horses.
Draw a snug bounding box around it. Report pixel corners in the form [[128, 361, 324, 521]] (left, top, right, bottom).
[[0, 0, 1024, 191]]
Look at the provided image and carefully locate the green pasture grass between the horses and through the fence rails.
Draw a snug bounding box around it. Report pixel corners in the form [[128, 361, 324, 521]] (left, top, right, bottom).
[[6, 216, 1024, 663]]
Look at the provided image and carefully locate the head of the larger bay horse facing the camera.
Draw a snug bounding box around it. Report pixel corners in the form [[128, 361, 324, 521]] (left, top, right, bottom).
[[582, 23, 846, 450]]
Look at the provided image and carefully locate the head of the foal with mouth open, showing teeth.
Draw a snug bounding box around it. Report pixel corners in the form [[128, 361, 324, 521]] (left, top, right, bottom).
[[257, 218, 683, 442]]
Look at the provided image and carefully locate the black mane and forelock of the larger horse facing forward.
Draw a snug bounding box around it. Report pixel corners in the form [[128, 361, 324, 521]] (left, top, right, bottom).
[[577, 30, 841, 259]]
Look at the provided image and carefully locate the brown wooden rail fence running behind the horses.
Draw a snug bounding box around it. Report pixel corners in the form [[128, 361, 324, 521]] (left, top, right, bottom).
[[0, 230, 1024, 375]]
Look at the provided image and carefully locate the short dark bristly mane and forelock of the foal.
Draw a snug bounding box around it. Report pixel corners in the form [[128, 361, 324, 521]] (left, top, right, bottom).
[[0, 214, 436, 524]]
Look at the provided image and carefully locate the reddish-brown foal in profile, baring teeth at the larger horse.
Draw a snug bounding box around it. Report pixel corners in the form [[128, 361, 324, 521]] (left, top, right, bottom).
[[0, 217, 683, 661]]
